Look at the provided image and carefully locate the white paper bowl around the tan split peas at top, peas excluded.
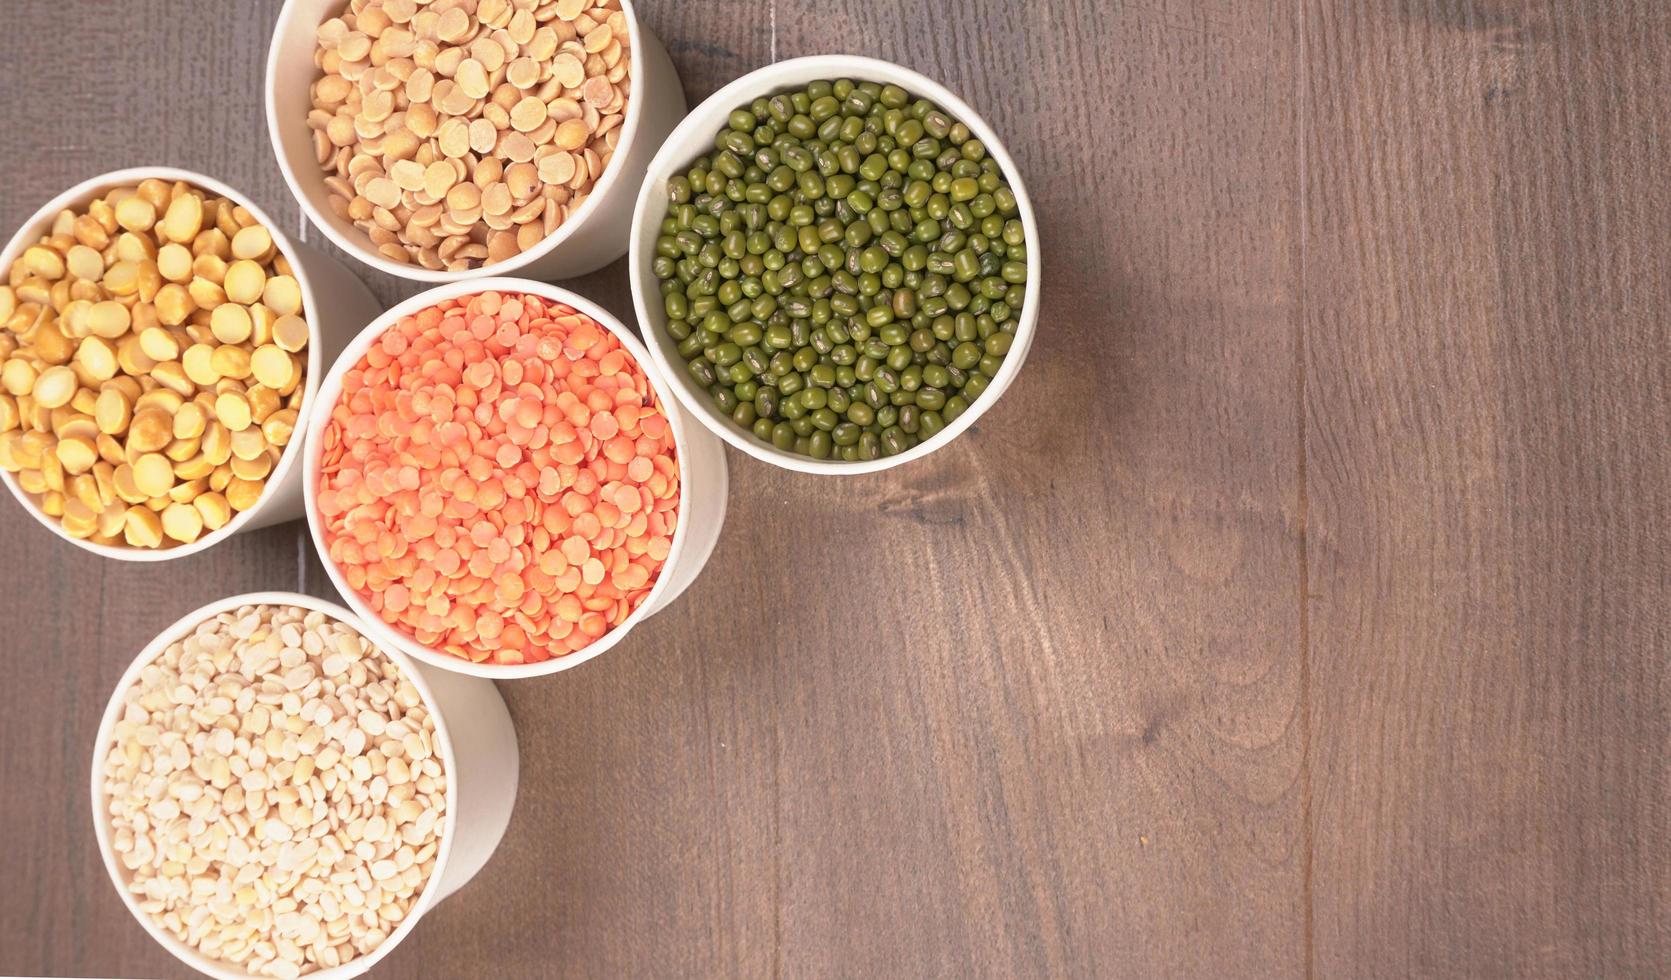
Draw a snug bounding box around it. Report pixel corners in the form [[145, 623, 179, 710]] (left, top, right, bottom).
[[266, 0, 685, 283]]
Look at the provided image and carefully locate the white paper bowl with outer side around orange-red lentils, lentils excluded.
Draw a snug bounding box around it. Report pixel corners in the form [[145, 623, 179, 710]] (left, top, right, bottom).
[[302, 279, 729, 679]]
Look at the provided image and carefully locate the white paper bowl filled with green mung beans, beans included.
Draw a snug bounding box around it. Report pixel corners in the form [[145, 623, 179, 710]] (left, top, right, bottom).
[[628, 55, 1039, 473]]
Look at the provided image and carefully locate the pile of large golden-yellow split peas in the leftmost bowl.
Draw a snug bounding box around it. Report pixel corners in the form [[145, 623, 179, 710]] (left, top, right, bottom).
[[0, 179, 307, 549]]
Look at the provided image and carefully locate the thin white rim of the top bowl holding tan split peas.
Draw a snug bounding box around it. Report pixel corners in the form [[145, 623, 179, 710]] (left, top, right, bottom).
[[262, 0, 643, 284]]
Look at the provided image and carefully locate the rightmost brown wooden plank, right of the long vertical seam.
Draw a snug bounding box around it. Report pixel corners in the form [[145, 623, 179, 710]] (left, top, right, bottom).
[[1302, 2, 1671, 977]]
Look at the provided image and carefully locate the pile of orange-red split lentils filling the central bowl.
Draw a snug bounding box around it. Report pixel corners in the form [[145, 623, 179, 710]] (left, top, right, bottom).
[[317, 285, 678, 664]]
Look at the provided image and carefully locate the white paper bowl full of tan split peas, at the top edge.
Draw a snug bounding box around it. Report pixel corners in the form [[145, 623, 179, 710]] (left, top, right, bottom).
[[266, 0, 685, 283]]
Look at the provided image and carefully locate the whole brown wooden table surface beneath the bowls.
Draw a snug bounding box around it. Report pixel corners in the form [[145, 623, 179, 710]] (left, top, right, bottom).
[[0, 0, 1671, 977]]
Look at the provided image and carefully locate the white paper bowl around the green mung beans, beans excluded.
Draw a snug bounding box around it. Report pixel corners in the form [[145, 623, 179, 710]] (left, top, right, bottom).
[[627, 55, 1043, 475]]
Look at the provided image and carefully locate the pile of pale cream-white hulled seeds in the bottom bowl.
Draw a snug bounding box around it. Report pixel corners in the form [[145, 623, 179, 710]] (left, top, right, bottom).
[[104, 605, 446, 977]]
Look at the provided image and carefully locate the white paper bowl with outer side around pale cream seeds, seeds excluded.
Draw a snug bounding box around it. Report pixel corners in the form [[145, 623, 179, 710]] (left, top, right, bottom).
[[92, 592, 518, 980]]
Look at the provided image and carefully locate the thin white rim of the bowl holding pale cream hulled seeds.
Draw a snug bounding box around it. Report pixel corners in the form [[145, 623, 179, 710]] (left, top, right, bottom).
[[90, 592, 458, 980]]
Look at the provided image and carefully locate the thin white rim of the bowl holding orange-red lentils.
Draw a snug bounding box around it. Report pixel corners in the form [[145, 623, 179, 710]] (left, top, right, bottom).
[[302, 276, 708, 681]]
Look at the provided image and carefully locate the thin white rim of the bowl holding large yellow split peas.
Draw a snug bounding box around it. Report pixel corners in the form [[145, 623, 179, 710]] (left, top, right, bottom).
[[0, 167, 324, 562]]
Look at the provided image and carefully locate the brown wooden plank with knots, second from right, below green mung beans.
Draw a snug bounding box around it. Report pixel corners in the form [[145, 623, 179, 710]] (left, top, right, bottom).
[[751, 3, 1300, 975]]
